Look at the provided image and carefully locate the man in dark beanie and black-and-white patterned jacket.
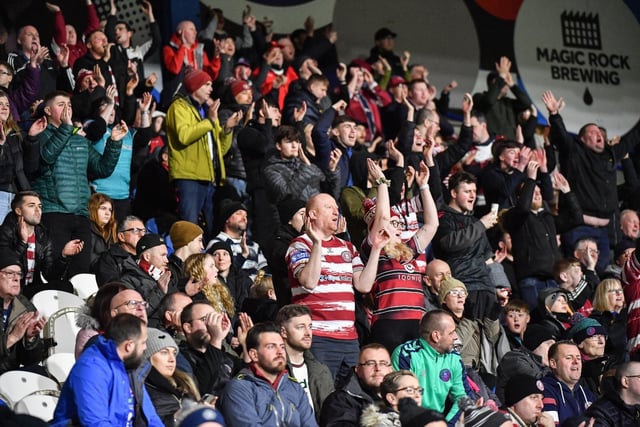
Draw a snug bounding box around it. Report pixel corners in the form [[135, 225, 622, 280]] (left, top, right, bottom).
[[207, 200, 269, 280]]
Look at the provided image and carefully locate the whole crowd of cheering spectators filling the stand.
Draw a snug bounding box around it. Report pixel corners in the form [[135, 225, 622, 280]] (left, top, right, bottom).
[[0, 0, 640, 427]]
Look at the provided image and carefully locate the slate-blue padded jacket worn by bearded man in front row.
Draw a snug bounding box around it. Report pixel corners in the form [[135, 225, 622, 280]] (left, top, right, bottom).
[[222, 369, 318, 427]]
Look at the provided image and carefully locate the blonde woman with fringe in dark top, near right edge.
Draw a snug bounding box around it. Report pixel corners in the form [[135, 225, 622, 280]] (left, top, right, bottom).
[[589, 279, 628, 364]]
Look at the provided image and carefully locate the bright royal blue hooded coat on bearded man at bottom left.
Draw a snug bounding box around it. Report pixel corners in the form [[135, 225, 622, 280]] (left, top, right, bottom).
[[50, 337, 164, 427]]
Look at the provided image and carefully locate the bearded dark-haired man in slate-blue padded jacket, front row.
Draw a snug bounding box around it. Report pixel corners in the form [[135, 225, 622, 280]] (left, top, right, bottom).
[[222, 322, 318, 427]]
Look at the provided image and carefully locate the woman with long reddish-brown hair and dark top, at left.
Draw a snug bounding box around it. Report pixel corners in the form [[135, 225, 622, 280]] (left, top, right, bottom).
[[89, 193, 118, 265]]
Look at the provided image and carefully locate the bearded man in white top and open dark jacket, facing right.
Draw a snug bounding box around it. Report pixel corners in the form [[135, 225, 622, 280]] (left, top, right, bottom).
[[276, 304, 333, 418]]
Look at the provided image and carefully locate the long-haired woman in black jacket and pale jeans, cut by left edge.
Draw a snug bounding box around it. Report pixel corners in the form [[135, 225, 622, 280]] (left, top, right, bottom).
[[0, 90, 46, 223]]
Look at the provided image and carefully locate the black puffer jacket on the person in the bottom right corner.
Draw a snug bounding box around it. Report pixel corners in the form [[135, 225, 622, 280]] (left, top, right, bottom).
[[585, 377, 640, 427]]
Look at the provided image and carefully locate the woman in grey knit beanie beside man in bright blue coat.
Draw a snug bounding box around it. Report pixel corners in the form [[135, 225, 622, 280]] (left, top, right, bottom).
[[144, 328, 200, 427]]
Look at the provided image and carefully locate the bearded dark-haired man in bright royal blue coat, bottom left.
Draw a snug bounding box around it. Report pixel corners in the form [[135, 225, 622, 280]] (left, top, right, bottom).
[[51, 313, 164, 427]]
